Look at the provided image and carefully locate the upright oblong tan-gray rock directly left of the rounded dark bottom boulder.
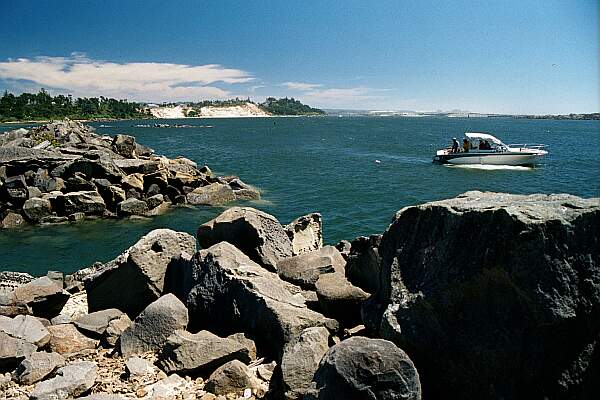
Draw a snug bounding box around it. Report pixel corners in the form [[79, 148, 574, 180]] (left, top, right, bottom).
[[281, 327, 329, 399]]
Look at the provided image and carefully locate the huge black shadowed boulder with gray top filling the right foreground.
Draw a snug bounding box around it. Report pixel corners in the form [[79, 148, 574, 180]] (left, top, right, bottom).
[[363, 192, 600, 399]]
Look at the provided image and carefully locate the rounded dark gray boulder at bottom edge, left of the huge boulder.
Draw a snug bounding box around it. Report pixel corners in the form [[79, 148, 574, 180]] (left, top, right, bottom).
[[309, 336, 422, 400]]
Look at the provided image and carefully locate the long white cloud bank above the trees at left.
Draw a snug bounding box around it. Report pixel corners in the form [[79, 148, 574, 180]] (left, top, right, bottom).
[[0, 53, 254, 102]]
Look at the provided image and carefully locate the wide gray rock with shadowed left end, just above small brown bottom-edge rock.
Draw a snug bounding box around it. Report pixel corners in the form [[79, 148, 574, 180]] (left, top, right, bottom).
[[157, 331, 251, 375]]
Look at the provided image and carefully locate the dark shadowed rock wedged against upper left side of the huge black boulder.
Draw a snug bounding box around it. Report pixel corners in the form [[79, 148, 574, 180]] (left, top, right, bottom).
[[346, 235, 381, 293]]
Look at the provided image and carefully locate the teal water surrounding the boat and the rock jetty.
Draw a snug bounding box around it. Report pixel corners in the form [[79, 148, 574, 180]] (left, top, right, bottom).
[[0, 117, 600, 274]]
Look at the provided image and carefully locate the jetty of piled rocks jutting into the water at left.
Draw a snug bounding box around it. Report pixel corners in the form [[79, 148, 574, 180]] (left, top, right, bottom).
[[0, 120, 260, 228]]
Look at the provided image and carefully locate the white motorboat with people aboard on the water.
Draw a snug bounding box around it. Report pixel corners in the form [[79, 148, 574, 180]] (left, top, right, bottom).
[[433, 132, 548, 165]]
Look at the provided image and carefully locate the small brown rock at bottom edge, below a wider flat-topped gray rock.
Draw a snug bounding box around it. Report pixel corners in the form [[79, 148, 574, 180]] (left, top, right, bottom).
[[204, 360, 258, 396]]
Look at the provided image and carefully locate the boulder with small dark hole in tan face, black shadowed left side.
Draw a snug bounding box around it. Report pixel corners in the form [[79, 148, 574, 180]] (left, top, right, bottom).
[[84, 229, 196, 318]]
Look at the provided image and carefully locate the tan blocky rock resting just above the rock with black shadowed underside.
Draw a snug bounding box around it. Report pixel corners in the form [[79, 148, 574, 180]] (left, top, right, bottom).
[[277, 246, 346, 290]]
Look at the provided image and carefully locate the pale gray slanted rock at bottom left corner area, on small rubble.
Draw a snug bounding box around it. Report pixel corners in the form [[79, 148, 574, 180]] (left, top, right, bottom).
[[30, 361, 97, 400]]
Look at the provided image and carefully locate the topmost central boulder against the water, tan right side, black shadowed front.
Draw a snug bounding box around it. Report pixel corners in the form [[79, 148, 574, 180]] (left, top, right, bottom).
[[197, 207, 293, 271]]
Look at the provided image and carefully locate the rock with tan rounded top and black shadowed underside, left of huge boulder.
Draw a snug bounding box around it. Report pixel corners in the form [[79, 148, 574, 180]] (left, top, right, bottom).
[[315, 273, 369, 327]]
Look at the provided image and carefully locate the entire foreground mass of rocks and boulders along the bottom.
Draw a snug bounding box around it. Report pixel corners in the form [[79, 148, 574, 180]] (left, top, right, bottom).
[[0, 192, 600, 400]]
